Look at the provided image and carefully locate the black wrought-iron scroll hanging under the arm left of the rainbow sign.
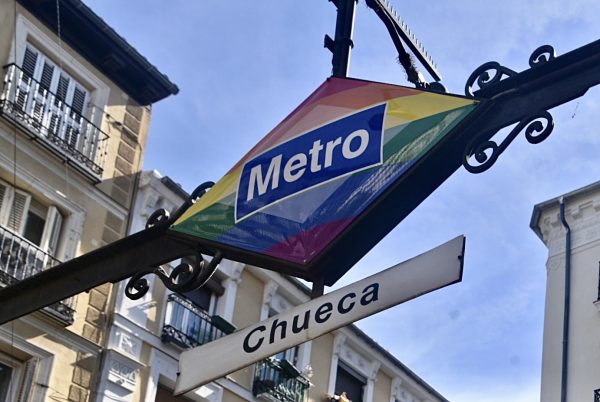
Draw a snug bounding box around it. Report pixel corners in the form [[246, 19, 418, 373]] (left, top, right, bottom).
[[125, 250, 223, 300]]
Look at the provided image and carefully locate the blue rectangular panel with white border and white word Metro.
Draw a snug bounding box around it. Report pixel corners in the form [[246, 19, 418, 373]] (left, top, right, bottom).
[[235, 103, 386, 221]]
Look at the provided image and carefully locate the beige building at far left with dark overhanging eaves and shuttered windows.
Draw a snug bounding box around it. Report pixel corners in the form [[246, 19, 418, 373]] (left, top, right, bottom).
[[0, 0, 178, 402]]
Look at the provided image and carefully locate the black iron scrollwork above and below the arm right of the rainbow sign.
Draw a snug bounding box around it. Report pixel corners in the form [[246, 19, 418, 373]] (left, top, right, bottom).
[[463, 45, 556, 173]]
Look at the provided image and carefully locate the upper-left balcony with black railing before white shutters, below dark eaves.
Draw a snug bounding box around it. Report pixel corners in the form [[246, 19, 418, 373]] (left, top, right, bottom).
[[0, 64, 109, 182]]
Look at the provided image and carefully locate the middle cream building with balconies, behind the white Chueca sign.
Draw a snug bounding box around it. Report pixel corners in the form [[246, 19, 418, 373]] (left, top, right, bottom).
[[105, 171, 446, 402]]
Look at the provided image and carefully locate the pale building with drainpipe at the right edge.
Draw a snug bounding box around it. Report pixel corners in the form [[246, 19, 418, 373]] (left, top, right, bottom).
[[531, 182, 600, 402]]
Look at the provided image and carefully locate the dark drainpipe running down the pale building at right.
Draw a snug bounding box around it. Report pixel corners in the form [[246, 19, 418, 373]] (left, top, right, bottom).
[[559, 197, 571, 402]]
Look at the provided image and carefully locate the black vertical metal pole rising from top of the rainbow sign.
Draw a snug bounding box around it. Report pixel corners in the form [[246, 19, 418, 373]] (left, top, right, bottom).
[[326, 0, 357, 78]]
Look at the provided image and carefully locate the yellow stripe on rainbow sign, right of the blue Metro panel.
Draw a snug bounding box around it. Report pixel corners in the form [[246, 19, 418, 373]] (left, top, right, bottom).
[[385, 93, 474, 130]]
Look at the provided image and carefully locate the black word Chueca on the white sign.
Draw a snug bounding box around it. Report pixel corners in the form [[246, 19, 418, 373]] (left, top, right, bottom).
[[242, 282, 379, 353]]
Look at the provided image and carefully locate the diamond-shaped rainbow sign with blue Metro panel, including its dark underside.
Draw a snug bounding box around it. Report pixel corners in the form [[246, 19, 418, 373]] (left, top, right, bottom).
[[171, 78, 478, 285]]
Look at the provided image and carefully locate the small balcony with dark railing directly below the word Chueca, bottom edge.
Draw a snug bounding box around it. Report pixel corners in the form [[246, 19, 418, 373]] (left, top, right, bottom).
[[252, 359, 310, 402]]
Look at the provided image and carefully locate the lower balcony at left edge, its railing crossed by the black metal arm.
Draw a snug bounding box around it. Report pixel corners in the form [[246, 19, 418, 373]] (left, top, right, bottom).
[[0, 226, 75, 325]]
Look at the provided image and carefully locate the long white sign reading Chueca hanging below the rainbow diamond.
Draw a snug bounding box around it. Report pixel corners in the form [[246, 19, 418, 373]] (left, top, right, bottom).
[[175, 236, 465, 395]]
